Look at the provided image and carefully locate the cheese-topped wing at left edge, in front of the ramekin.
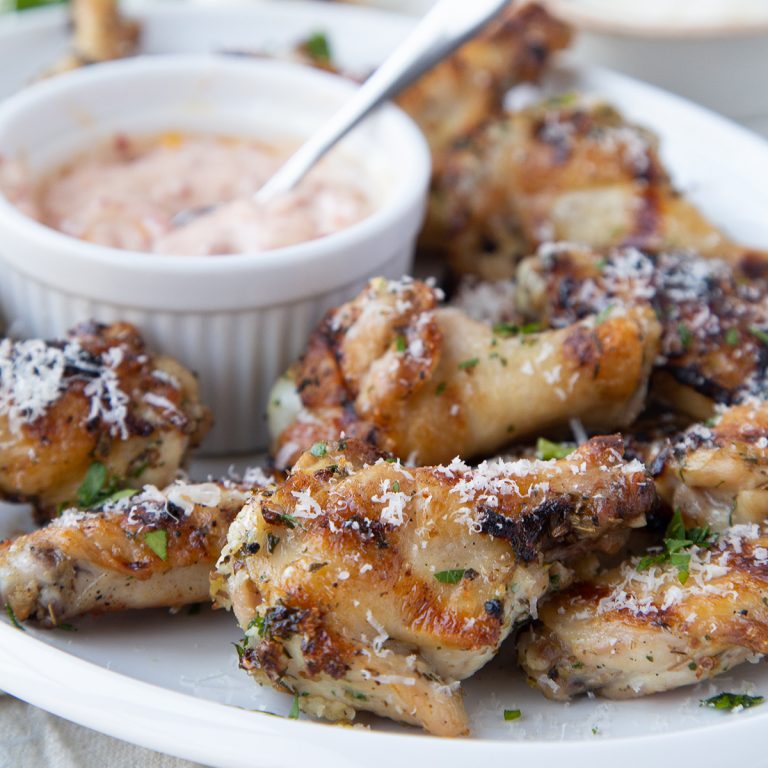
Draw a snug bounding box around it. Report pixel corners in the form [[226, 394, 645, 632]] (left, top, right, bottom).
[[0, 323, 210, 516]]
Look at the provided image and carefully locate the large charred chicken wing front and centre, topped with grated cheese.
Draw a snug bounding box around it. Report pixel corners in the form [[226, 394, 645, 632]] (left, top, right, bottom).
[[212, 436, 654, 736]]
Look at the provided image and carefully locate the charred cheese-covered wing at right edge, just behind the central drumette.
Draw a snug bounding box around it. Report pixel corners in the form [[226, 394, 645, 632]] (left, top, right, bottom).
[[516, 244, 768, 420]]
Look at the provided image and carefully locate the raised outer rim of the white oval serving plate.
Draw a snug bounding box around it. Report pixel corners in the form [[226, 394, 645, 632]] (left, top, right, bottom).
[[0, 0, 768, 768]]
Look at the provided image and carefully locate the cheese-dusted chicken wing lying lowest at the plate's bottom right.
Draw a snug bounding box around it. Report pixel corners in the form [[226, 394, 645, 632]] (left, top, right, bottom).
[[518, 524, 768, 700]]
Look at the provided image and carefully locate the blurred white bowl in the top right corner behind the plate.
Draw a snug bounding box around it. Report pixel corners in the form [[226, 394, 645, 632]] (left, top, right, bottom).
[[546, 0, 768, 129]]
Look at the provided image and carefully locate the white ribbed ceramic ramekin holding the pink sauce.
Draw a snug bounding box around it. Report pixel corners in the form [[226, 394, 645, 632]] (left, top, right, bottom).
[[0, 55, 430, 453]]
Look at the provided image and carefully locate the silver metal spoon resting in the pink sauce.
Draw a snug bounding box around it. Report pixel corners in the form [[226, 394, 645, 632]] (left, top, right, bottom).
[[172, 0, 509, 226]]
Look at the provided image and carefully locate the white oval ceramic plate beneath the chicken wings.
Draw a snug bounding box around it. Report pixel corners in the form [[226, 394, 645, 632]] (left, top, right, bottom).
[[0, 0, 768, 768]]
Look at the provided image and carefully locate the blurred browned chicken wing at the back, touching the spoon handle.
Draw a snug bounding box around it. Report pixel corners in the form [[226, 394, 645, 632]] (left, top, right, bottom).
[[397, 3, 571, 171]]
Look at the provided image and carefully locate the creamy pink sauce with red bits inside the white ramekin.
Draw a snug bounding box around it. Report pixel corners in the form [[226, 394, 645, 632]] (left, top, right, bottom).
[[30, 133, 372, 256]]
